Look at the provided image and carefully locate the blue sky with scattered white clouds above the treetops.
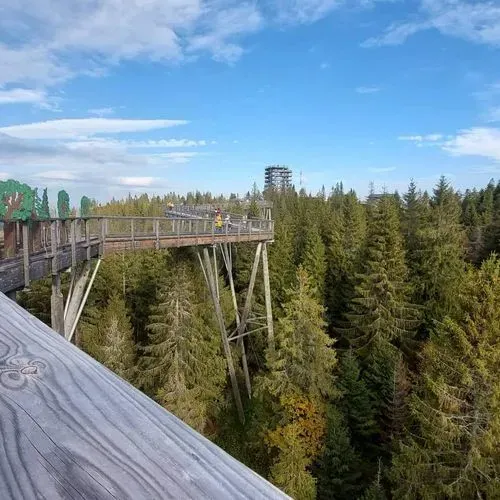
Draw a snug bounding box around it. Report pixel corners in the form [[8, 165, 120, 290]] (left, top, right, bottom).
[[0, 0, 500, 201]]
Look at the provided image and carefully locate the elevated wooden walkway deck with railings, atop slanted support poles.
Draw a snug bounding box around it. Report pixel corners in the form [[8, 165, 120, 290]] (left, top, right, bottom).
[[0, 215, 274, 293]]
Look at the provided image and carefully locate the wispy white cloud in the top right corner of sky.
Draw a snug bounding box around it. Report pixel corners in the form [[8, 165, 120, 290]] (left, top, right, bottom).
[[362, 0, 500, 47]]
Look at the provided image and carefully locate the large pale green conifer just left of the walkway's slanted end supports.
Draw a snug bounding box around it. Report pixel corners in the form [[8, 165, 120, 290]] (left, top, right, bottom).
[[139, 263, 225, 431]]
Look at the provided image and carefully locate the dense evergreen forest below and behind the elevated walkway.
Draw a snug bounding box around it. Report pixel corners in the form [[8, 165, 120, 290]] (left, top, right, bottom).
[[20, 177, 500, 500]]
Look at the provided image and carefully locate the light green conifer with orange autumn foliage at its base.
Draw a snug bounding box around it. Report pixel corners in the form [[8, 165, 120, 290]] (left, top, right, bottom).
[[256, 267, 336, 499]]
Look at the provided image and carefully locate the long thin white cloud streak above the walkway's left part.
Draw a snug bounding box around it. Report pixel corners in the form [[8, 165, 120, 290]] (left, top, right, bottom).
[[0, 118, 188, 139]]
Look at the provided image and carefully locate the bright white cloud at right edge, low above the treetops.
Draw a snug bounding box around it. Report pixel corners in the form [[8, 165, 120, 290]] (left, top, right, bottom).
[[443, 127, 500, 161]]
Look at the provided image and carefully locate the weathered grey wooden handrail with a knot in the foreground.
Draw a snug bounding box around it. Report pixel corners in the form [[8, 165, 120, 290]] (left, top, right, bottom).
[[0, 293, 287, 500]]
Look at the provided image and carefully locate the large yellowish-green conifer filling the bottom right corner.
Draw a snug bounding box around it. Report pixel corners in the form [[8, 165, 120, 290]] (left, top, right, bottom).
[[393, 257, 500, 499]]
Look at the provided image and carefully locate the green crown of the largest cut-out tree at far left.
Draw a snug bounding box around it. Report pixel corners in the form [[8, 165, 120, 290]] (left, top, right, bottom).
[[0, 179, 35, 221]]
